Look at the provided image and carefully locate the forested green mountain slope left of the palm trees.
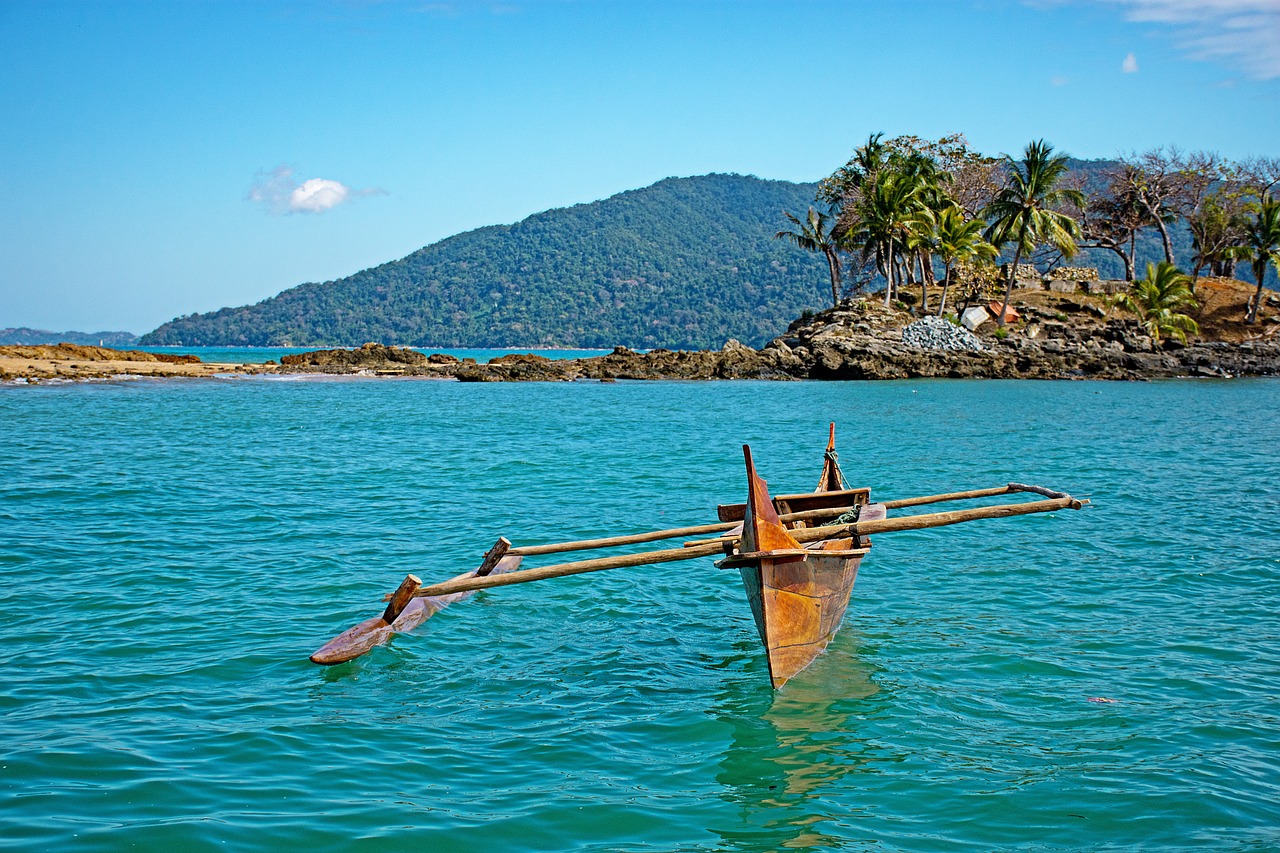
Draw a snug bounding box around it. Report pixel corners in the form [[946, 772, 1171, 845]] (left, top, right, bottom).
[[141, 174, 831, 348]]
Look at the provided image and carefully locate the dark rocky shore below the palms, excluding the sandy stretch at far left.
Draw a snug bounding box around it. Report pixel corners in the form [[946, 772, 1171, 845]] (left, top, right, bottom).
[[272, 294, 1280, 382]]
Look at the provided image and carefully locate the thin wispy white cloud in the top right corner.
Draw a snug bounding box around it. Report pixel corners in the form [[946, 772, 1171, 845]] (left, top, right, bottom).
[[1025, 0, 1280, 79]]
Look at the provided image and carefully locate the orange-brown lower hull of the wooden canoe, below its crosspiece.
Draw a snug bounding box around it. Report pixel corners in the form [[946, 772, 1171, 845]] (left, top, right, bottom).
[[739, 540, 865, 688]]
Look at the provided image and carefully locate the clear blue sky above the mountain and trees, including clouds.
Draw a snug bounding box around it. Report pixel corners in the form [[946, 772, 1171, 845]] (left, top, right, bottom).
[[0, 0, 1280, 333]]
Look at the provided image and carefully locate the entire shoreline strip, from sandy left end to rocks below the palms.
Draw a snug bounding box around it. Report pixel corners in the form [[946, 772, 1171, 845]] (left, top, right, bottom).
[[0, 286, 1280, 382]]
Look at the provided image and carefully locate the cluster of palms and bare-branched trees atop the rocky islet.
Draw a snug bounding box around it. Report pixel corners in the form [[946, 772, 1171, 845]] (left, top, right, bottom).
[[792, 133, 1280, 337]]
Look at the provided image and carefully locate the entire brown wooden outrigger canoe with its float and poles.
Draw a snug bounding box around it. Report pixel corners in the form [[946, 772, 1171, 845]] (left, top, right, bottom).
[[311, 424, 1088, 688]]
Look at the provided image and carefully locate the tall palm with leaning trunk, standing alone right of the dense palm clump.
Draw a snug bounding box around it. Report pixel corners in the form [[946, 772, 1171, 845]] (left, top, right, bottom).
[[983, 140, 1084, 325]]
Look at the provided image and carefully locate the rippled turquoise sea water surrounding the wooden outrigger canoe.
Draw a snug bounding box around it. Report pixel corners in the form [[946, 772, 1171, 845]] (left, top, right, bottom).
[[0, 378, 1280, 853]]
